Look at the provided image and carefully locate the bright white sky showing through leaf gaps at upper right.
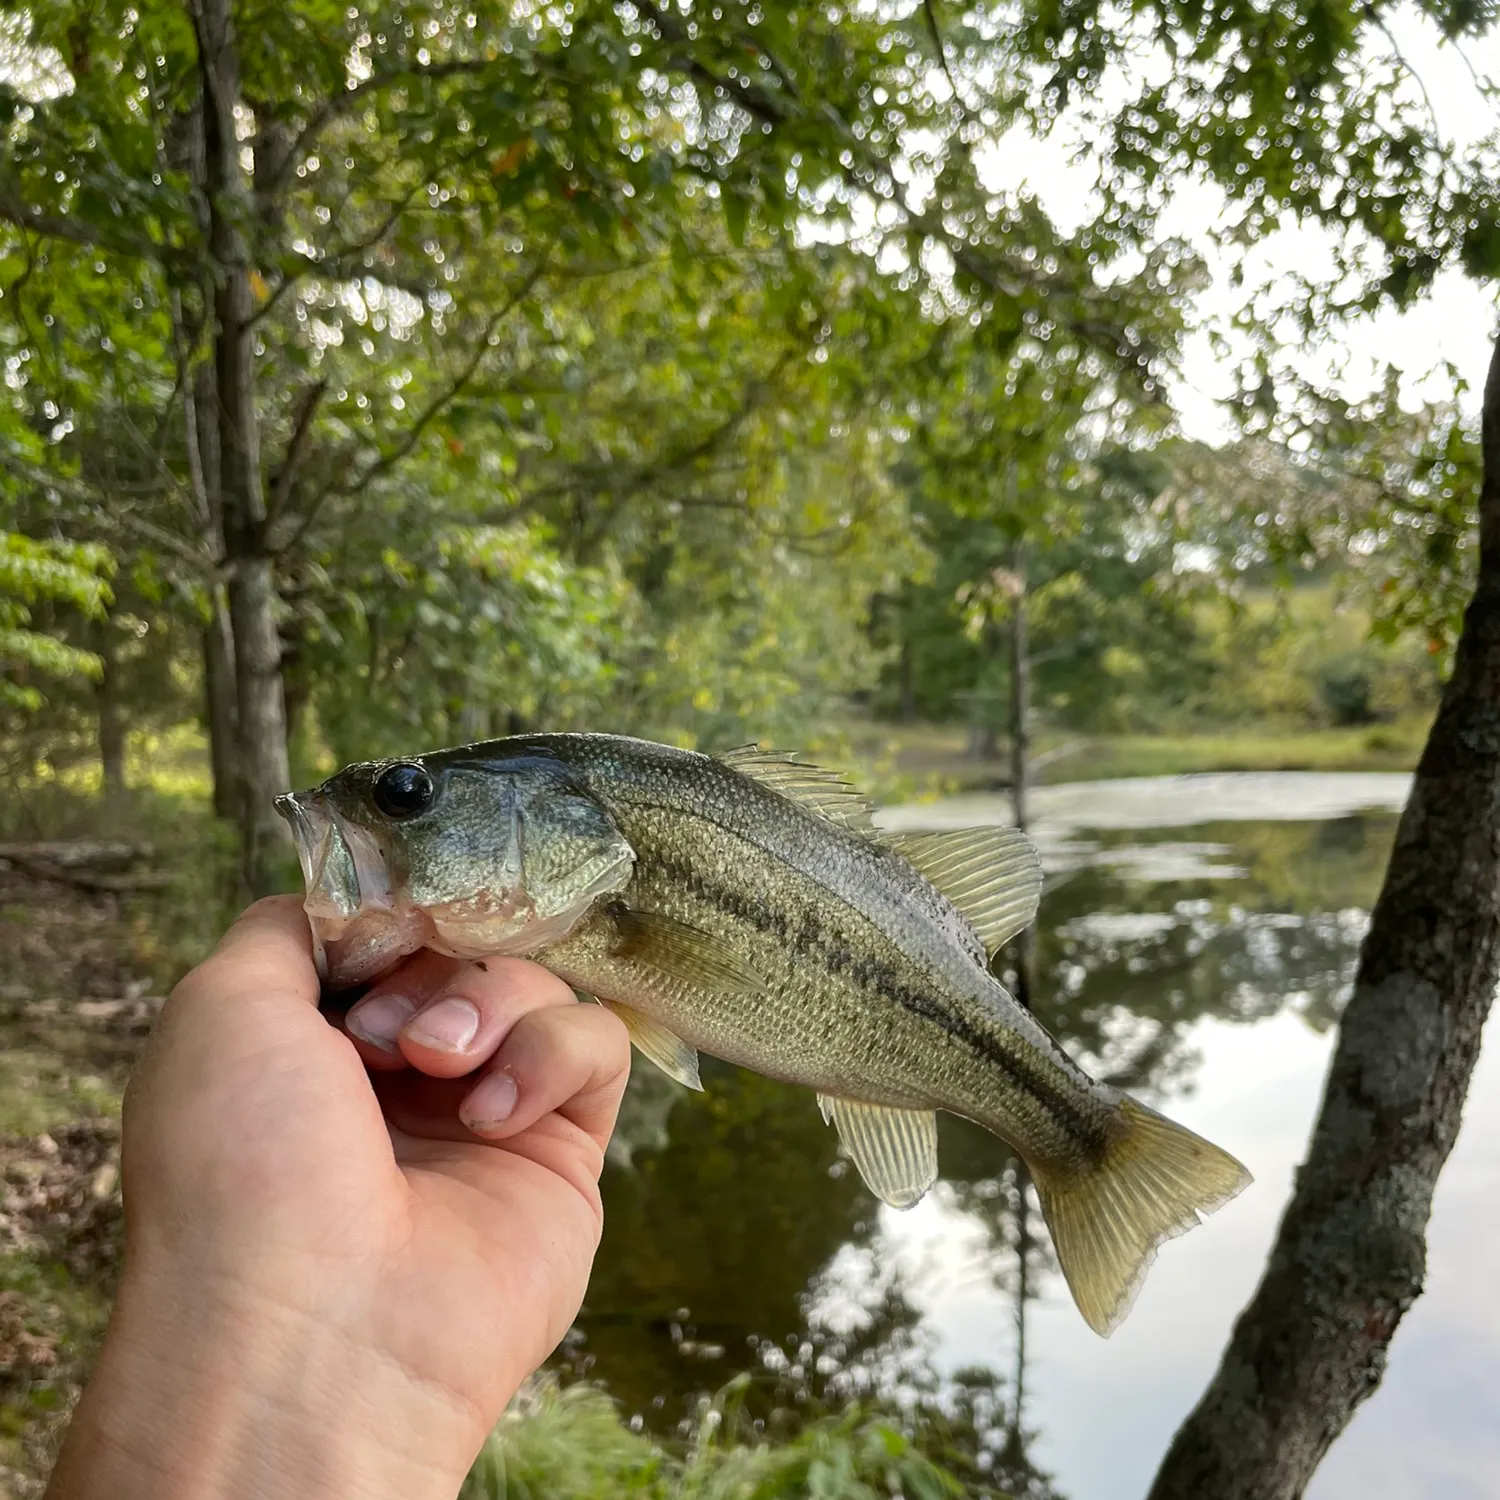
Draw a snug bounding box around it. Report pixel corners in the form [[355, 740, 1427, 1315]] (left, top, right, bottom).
[[986, 9, 1500, 443]]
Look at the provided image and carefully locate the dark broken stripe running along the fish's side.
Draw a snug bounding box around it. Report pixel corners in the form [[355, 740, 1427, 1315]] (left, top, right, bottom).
[[651, 855, 1089, 1134]]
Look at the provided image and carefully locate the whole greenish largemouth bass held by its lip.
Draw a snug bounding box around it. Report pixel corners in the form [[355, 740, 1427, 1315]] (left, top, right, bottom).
[[276, 734, 1251, 1335]]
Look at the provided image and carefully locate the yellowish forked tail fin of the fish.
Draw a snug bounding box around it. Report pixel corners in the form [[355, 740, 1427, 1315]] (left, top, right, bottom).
[[1032, 1098, 1251, 1338]]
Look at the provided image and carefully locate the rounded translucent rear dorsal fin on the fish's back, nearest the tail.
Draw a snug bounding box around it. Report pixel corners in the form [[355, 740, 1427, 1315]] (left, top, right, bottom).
[[881, 828, 1041, 956]]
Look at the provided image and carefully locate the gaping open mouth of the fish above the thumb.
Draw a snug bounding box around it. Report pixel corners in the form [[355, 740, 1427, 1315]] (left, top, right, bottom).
[[276, 791, 432, 989]]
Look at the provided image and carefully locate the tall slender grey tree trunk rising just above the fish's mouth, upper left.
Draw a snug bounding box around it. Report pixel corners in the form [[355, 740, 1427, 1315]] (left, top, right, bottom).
[[194, 0, 291, 896]]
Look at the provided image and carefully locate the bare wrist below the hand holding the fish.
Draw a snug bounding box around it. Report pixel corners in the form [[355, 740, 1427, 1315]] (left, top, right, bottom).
[[48, 1274, 485, 1500]]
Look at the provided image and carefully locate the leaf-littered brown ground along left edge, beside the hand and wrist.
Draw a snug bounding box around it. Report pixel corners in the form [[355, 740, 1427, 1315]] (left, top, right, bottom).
[[0, 863, 162, 1500]]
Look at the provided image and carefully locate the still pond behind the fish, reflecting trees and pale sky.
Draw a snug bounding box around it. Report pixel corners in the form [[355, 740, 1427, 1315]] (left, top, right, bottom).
[[566, 774, 1500, 1500]]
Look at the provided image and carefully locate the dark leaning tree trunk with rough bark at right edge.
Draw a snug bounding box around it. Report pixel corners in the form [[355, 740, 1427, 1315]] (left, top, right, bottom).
[[1151, 334, 1500, 1500]]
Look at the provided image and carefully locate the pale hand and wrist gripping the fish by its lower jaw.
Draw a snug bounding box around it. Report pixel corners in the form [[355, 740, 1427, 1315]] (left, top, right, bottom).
[[48, 897, 630, 1500]]
